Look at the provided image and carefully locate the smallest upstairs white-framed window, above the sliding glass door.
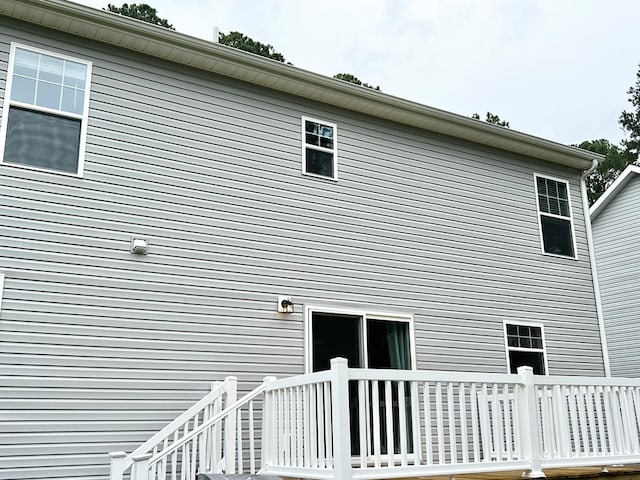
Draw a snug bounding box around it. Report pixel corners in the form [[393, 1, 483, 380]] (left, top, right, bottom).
[[302, 117, 338, 180]]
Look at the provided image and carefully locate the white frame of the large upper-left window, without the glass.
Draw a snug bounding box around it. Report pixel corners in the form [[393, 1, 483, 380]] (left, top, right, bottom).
[[0, 42, 93, 177]]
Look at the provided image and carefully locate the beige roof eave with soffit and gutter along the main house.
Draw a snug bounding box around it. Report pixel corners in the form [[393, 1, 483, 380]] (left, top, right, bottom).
[[0, 0, 604, 170]]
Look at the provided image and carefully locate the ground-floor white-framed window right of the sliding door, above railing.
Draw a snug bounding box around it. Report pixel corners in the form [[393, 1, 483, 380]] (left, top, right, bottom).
[[504, 321, 549, 375]]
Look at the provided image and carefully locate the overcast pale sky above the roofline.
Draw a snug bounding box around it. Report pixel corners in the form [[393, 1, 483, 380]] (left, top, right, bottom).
[[71, 0, 640, 144]]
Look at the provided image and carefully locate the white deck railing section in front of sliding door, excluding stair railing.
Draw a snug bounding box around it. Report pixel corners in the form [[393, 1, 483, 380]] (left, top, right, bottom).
[[263, 359, 640, 480]]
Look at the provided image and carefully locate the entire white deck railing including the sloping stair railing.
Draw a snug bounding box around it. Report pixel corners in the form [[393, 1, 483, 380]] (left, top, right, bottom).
[[111, 359, 640, 480]]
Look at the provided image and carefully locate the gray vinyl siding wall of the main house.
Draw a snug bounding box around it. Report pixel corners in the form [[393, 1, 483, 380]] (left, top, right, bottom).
[[0, 15, 603, 480]]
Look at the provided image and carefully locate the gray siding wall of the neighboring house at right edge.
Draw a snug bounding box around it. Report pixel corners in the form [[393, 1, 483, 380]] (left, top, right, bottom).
[[593, 173, 640, 377]]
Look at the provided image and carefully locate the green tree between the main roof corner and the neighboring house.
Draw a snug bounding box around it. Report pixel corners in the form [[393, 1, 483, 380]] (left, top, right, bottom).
[[574, 138, 634, 205]]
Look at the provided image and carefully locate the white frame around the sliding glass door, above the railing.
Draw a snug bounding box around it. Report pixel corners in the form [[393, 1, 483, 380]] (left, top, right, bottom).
[[304, 305, 417, 373]]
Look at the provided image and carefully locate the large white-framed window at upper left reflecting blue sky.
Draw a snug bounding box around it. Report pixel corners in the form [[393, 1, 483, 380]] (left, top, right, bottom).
[[0, 43, 91, 176]]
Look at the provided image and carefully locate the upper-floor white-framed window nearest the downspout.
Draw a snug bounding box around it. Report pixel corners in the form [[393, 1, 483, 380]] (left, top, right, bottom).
[[534, 174, 578, 259]]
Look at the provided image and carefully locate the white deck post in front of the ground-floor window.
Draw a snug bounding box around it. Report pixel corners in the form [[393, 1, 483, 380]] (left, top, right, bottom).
[[518, 367, 546, 478]]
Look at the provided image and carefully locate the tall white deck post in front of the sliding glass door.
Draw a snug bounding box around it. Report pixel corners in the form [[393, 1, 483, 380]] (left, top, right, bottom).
[[331, 358, 352, 480]]
